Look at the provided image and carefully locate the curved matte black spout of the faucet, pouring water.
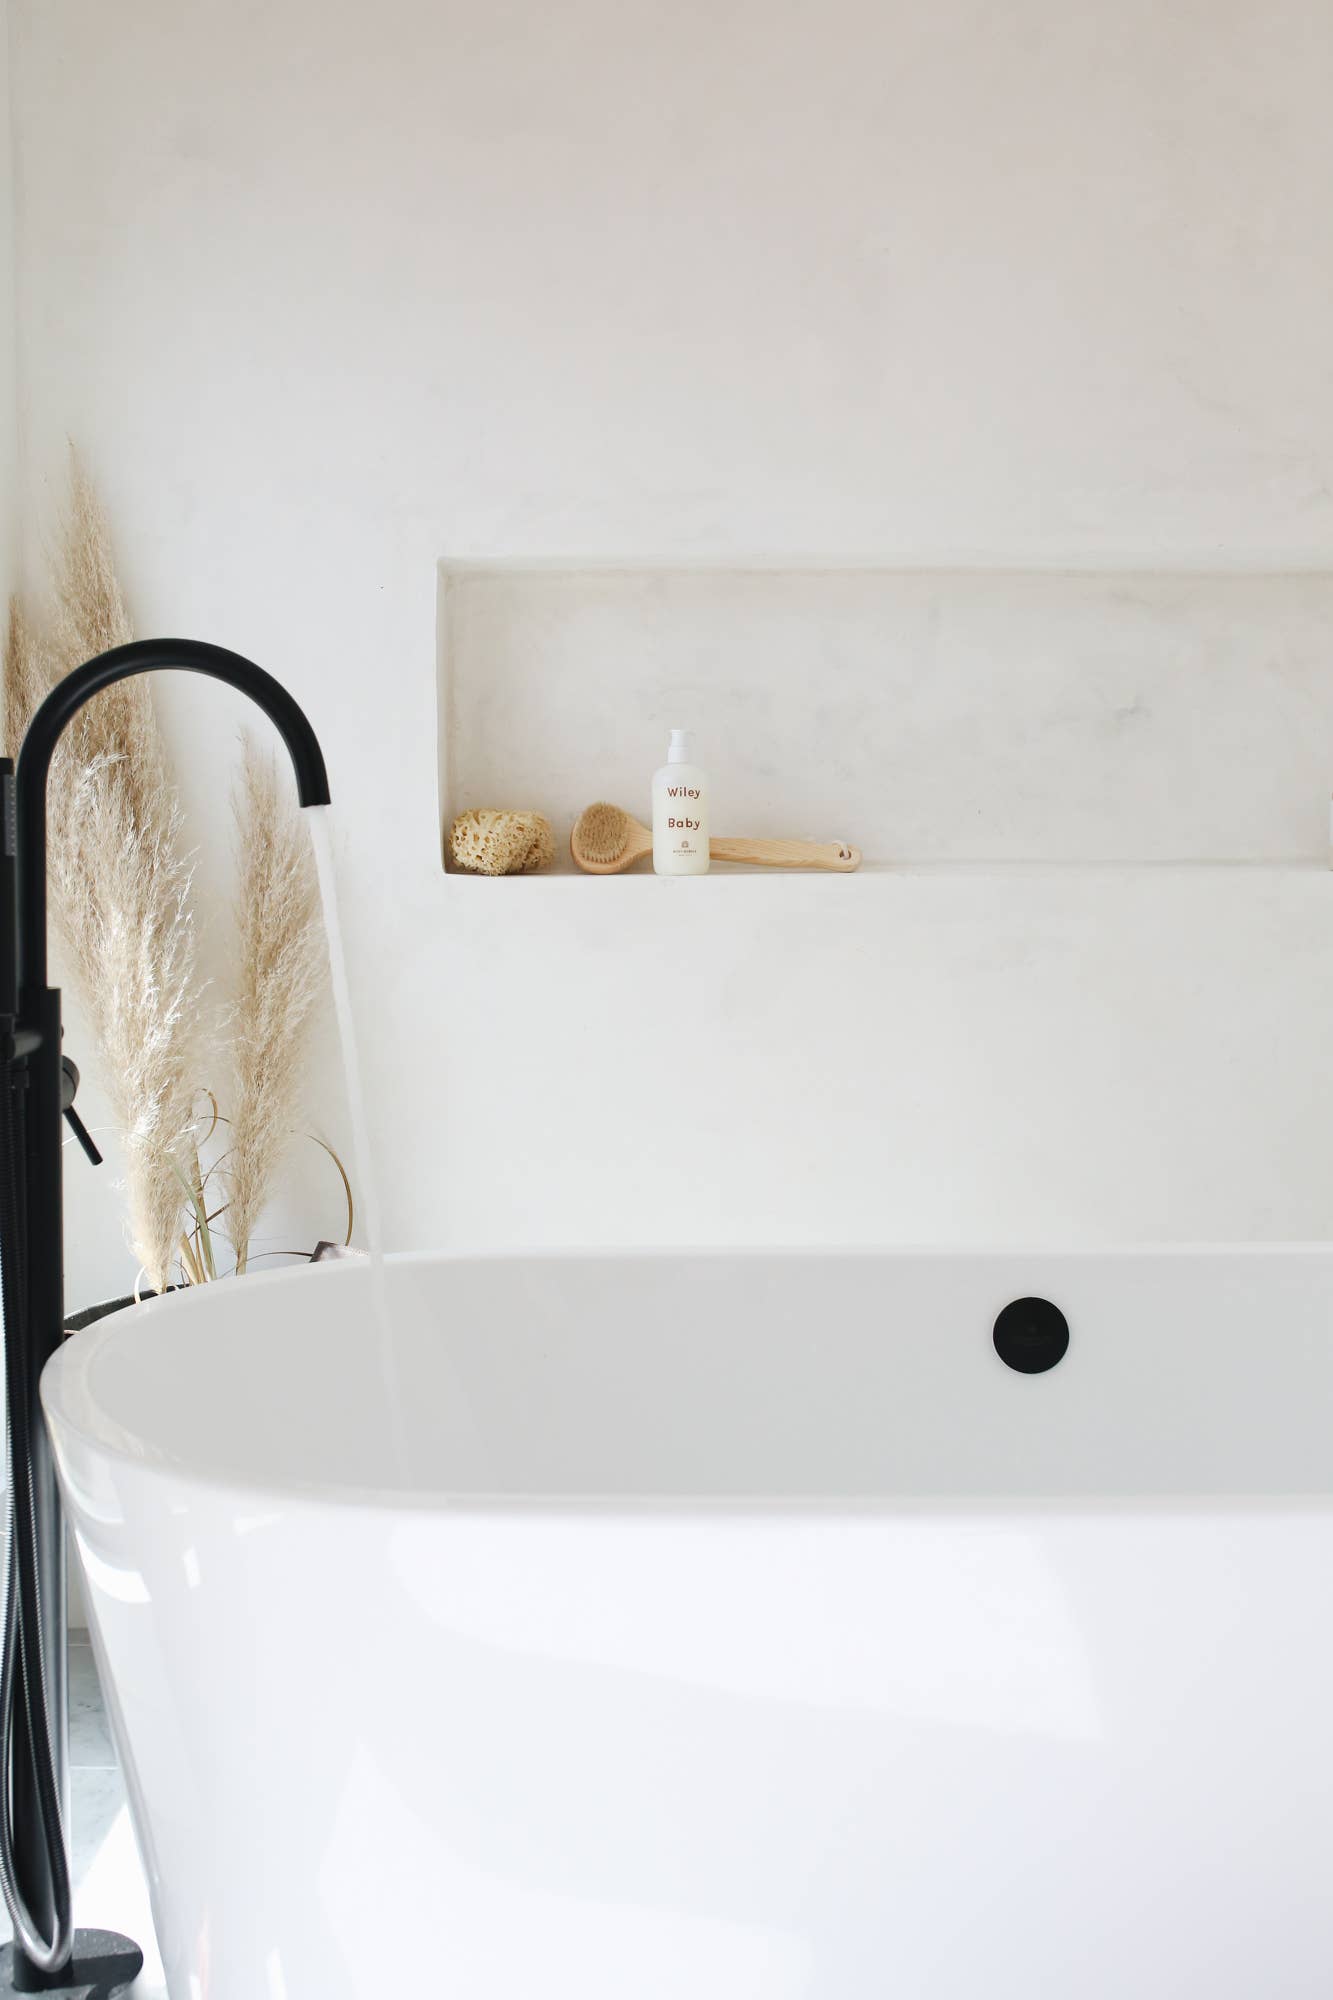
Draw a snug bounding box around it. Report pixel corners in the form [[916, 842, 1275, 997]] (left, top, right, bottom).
[[14, 638, 328, 992]]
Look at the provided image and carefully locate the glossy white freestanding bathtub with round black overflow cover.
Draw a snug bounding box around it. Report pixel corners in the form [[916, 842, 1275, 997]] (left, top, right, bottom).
[[44, 1248, 1333, 2000]]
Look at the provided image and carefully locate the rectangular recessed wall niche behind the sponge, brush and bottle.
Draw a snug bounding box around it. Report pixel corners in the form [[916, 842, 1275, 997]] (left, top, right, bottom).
[[438, 562, 1333, 870]]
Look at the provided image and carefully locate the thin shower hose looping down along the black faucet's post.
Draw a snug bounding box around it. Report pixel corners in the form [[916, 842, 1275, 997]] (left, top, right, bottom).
[[0, 1052, 74, 1972]]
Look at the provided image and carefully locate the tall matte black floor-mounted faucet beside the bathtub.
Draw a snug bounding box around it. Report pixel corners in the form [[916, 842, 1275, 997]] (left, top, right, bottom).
[[0, 638, 328, 2000]]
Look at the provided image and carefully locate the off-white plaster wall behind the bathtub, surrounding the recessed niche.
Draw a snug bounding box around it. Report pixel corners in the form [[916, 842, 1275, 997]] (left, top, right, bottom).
[[12, 0, 1333, 1290]]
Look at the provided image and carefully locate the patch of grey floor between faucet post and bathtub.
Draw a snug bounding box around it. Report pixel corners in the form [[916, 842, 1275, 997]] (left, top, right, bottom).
[[0, 1632, 166, 2000]]
